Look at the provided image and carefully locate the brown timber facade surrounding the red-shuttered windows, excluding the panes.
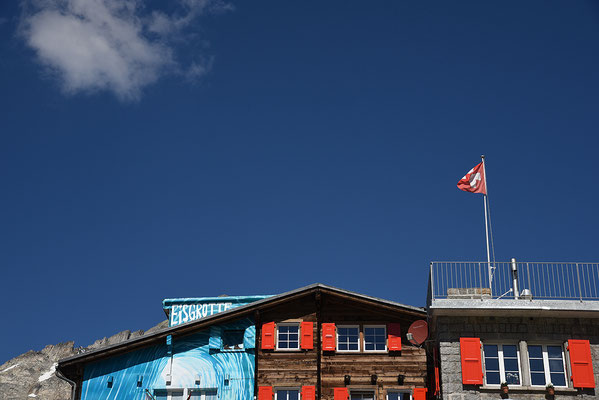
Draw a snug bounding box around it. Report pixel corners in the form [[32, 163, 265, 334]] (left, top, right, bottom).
[[255, 290, 427, 400]]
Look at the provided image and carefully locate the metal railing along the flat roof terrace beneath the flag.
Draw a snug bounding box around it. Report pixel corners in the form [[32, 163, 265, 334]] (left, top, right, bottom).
[[429, 260, 599, 301]]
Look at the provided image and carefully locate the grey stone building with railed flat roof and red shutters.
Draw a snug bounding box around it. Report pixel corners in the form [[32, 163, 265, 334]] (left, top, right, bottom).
[[427, 260, 599, 400]]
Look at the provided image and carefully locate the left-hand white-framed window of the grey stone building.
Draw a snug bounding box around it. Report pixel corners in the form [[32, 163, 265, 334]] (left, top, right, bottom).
[[483, 344, 522, 386]]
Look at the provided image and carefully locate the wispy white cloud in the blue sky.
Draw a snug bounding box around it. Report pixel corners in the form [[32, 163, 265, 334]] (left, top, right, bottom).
[[19, 0, 230, 101]]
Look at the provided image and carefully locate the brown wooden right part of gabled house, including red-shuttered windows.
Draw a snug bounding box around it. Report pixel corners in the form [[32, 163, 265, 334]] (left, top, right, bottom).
[[255, 284, 427, 400]]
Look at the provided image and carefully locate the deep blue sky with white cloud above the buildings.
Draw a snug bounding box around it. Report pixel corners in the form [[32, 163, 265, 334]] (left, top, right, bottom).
[[0, 0, 599, 363]]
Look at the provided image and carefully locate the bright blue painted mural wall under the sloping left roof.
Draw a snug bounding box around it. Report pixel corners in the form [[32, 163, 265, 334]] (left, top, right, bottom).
[[81, 318, 256, 400]]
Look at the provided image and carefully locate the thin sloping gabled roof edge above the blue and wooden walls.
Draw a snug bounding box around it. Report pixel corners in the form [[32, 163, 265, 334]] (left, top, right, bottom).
[[57, 283, 426, 372]]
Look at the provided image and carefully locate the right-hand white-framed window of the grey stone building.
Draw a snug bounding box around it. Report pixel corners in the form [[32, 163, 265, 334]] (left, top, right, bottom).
[[528, 345, 568, 387]]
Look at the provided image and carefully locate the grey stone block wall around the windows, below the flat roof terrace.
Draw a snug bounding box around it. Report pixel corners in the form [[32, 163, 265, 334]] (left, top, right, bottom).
[[435, 316, 599, 400]]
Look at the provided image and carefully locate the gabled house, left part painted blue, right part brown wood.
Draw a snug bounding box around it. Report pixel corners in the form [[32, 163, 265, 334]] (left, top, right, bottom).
[[57, 284, 429, 400]]
